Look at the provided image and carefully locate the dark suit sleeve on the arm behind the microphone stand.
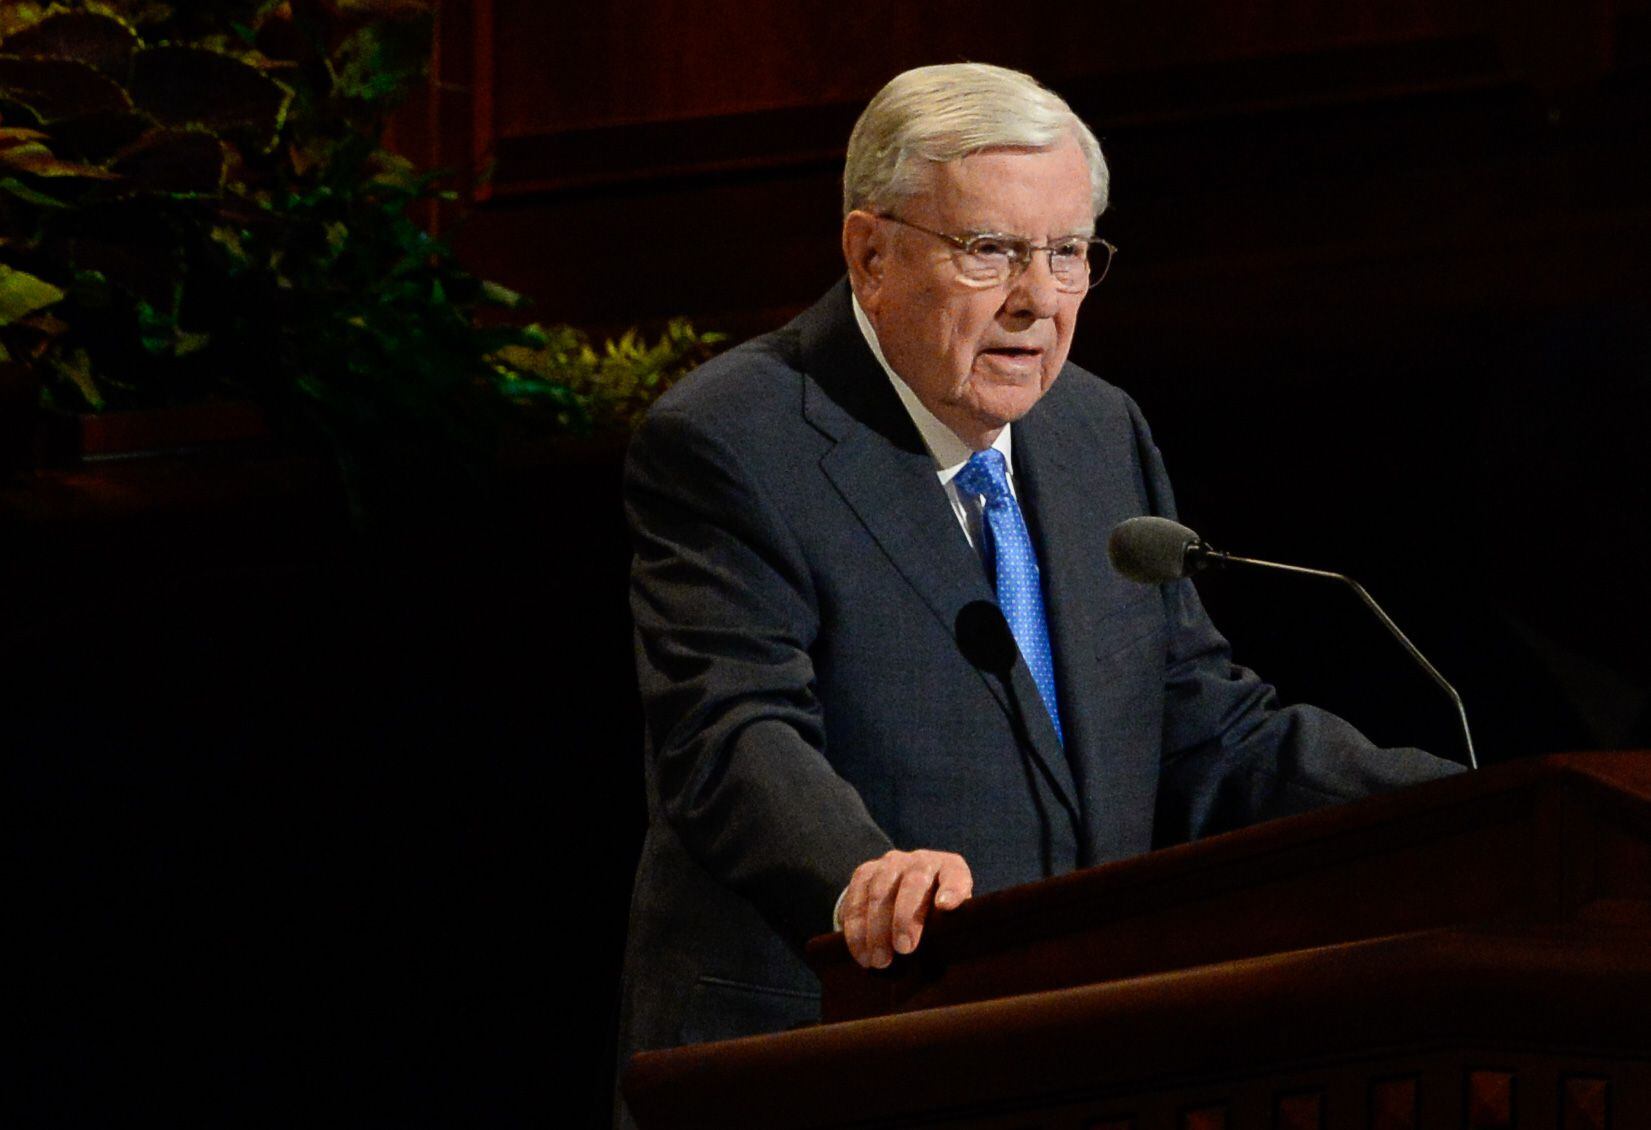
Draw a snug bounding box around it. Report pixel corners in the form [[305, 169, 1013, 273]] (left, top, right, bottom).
[[1131, 403, 1463, 844]]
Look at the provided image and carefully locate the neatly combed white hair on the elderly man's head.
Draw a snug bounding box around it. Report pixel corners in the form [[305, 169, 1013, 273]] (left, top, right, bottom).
[[842, 63, 1109, 215]]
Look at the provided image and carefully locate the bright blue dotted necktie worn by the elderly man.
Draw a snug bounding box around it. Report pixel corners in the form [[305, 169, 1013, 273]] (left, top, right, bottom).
[[953, 448, 1067, 743]]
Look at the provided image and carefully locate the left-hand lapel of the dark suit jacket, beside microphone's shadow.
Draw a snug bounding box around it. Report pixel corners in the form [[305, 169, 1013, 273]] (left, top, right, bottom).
[[799, 284, 1081, 828]]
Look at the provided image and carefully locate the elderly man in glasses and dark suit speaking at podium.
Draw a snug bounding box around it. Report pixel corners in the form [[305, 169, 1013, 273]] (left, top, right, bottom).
[[621, 57, 1453, 1110]]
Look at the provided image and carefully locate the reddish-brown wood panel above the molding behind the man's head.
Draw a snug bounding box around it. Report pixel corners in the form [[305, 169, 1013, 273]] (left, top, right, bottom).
[[477, 0, 1506, 137]]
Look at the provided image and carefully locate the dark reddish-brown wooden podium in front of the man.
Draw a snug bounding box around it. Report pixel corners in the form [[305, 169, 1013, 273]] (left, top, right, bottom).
[[626, 753, 1651, 1130]]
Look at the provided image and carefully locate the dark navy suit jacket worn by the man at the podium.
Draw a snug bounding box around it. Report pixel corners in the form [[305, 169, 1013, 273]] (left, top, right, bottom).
[[621, 283, 1453, 1103]]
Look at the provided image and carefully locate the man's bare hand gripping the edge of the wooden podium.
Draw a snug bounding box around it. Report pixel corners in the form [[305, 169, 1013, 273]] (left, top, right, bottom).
[[839, 851, 974, 970]]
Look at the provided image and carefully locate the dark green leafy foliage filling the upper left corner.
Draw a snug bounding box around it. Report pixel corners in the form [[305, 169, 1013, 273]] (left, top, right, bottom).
[[0, 0, 717, 469]]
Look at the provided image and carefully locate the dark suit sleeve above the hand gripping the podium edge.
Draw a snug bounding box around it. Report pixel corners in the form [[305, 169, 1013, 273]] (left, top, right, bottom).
[[626, 401, 892, 942]]
